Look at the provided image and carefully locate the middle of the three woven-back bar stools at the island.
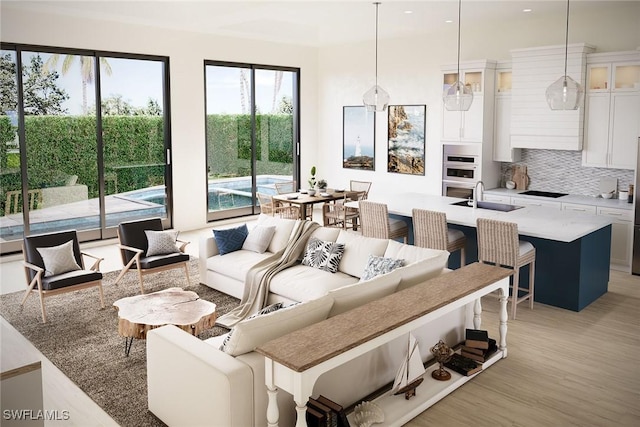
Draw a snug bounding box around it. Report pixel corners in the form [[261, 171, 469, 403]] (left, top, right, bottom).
[[411, 208, 467, 267]]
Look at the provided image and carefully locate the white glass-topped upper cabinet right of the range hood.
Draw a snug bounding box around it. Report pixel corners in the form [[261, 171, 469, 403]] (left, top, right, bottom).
[[582, 51, 640, 169]]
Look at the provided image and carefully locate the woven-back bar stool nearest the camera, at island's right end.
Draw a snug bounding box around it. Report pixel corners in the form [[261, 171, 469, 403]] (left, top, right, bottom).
[[476, 218, 536, 319]]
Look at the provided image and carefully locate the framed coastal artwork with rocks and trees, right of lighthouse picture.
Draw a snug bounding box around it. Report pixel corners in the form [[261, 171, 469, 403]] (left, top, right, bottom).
[[387, 105, 427, 175]]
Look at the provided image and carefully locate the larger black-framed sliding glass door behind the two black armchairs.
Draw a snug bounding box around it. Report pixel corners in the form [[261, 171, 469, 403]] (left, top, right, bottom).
[[0, 45, 171, 253]]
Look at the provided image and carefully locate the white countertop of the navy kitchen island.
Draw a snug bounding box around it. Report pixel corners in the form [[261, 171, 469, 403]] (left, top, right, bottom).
[[360, 193, 611, 242]]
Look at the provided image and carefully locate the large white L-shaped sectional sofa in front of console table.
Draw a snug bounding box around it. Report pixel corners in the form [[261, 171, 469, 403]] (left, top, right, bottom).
[[147, 218, 470, 427]]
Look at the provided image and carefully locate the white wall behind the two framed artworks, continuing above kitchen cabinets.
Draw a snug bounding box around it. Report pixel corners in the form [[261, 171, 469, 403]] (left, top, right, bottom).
[[316, 1, 640, 199]]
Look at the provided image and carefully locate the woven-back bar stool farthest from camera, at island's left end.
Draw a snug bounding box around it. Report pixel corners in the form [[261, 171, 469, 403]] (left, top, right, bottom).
[[358, 200, 409, 243]]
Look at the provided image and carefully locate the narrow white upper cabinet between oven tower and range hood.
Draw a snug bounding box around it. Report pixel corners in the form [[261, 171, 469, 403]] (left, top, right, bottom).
[[493, 62, 521, 163]]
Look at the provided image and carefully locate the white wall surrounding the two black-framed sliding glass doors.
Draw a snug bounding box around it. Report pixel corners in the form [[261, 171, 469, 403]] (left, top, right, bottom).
[[0, 3, 318, 230]]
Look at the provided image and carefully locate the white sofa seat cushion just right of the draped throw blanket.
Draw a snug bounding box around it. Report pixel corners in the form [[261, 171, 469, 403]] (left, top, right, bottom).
[[269, 264, 358, 301]]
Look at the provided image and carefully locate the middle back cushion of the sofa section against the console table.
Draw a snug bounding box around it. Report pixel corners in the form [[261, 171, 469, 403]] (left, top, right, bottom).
[[329, 271, 400, 317]]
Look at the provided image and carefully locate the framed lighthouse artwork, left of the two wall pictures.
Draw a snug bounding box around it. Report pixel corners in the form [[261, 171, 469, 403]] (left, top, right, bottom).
[[342, 105, 376, 171]]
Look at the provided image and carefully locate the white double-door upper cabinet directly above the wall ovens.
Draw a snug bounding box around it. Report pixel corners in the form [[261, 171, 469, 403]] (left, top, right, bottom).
[[441, 60, 496, 143]]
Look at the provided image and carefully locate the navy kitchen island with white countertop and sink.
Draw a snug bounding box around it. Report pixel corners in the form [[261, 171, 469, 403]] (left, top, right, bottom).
[[358, 193, 611, 311]]
